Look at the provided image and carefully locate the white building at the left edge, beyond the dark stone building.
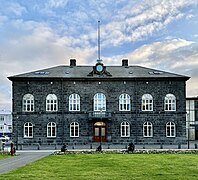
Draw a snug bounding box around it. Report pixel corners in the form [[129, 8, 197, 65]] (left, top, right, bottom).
[[0, 110, 12, 137]]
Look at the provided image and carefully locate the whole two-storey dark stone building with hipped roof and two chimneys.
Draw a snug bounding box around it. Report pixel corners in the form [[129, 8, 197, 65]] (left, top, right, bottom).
[[8, 59, 189, 148]]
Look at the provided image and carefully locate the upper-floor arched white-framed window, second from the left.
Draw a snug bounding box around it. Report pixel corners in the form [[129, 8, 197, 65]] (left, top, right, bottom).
[[46, 94, 58, 111]]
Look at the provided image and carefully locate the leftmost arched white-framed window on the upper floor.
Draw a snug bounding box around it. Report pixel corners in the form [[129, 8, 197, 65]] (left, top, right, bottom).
[[23, 94, 34, 112]]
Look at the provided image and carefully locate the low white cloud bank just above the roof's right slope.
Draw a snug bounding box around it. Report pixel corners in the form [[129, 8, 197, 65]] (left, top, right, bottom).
[[103, 39, 198, 96]]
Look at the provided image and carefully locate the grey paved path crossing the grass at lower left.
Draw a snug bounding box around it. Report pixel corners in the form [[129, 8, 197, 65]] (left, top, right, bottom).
[[0, 150, 54, 174]]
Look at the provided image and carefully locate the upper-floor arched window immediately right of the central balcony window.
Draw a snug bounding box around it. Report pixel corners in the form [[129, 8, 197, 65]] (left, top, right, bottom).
[[119, 94, 131, 111]]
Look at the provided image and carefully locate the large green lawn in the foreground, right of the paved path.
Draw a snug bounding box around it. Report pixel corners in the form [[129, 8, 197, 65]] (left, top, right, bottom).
[[0, 154, 198, 180]]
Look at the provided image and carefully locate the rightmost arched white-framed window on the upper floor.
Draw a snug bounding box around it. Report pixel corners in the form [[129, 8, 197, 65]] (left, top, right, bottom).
[[164, 94, 176, 111]]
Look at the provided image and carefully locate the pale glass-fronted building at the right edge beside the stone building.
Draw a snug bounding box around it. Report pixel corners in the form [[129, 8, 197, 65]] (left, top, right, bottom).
[[186, 96, 198, 140]]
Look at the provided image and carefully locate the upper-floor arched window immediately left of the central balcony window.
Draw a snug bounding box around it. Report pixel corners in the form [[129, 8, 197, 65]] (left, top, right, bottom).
[[69, 94, 80, 111]]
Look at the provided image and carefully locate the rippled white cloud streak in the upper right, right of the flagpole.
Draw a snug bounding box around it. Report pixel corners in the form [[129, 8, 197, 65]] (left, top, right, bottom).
[[102, 0, 198, 46]]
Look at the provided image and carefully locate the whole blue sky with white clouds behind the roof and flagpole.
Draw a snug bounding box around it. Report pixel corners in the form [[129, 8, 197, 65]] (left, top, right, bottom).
[[0, 0, 198, 110]]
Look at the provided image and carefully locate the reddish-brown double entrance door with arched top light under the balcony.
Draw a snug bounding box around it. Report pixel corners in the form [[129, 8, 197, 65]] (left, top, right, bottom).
[[93, 122, 106, 142]]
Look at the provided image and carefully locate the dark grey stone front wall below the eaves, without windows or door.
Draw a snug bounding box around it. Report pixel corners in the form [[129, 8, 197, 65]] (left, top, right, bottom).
[[13, 78, 186, 145]]
